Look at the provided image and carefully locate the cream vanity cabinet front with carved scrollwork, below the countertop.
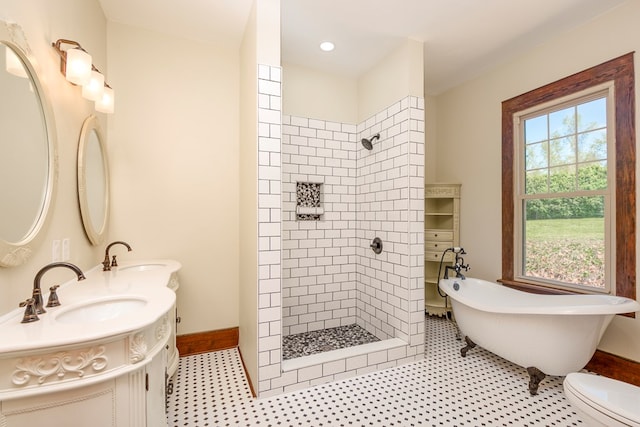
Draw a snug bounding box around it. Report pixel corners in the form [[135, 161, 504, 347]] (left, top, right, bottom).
[[0, 307, 175, 427]]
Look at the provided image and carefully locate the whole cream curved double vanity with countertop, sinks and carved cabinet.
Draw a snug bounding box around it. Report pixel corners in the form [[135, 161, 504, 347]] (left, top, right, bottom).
[[0, 260, 181, 427]]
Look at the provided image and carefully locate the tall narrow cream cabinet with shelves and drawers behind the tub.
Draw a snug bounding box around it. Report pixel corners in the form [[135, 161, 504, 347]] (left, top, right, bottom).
[[424, 184, 460, 316]]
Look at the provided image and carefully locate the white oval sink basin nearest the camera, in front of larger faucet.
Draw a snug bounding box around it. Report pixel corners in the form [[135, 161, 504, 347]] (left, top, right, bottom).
[[55, 296, 147, 323]]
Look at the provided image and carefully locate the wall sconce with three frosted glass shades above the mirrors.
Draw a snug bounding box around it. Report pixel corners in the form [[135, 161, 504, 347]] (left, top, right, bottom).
[[51, 39, 114, 114]]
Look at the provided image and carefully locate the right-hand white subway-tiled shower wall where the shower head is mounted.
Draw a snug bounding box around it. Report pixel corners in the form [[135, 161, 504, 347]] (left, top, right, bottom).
[[356, 97, 424, 348]]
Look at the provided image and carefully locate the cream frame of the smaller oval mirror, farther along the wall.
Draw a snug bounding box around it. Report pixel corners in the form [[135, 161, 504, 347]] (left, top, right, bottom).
[[78, 115, 109, 245]]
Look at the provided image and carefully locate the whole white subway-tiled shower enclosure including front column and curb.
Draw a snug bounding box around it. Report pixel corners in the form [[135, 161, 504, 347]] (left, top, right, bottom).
[[256, 66, 424, 397]]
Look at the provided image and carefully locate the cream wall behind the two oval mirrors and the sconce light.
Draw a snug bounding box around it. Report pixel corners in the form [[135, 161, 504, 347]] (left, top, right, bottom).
[[0, 0, 110, 314]]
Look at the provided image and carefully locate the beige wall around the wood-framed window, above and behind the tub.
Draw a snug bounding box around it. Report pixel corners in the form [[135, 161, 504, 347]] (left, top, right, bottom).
[[436, 2, 640, 360]]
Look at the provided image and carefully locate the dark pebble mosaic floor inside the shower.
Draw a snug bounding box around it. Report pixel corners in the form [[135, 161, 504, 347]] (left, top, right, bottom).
[[282, 324, 380, 360]]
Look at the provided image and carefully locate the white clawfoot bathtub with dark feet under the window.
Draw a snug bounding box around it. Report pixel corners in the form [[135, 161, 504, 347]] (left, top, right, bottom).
[[439, 278, 640, 395]]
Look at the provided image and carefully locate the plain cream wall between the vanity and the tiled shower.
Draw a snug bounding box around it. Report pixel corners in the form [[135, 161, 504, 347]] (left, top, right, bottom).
[[108, 22, 240, 334]]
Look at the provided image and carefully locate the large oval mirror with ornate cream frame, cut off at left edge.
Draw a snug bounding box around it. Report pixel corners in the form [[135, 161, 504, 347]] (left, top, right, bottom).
[[0, 21, 57, 267]]
